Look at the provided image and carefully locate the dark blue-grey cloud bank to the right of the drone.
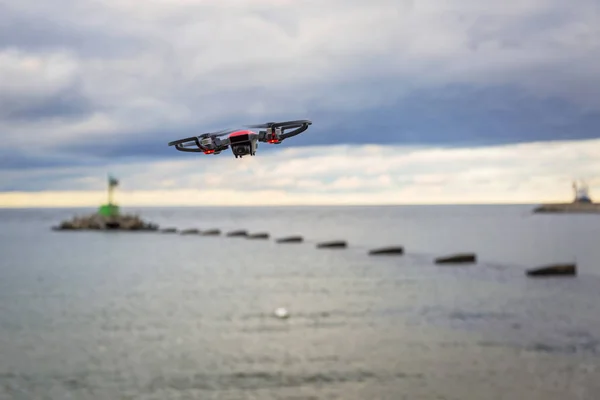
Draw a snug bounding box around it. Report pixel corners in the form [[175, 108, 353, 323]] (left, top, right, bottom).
[[288, 85, 600, 146]]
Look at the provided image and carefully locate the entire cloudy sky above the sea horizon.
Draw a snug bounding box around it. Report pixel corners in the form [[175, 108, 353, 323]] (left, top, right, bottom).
[[0, 0, 600, 207]]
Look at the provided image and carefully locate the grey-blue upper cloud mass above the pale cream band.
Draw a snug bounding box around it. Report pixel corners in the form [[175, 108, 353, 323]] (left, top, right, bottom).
[[0, 0, 600, 158]]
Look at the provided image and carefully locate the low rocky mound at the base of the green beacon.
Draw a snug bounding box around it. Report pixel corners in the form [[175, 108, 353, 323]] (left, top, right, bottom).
[[52, 214, 159, 231]]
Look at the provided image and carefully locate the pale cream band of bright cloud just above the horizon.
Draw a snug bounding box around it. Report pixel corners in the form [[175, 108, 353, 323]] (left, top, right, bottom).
[[0, 140, 600, 207]]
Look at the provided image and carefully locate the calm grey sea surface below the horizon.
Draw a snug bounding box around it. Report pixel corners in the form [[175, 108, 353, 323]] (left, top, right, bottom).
[[0, 205, 600, 400]]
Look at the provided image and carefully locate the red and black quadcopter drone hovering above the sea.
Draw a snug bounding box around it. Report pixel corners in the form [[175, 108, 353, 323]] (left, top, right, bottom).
[[169, 119, 312, 158]]
